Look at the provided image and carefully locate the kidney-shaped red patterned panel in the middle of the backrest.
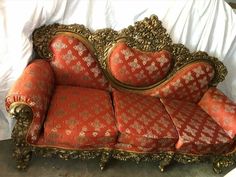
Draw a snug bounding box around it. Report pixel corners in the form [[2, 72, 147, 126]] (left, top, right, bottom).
[[108, 42, 172, 86]]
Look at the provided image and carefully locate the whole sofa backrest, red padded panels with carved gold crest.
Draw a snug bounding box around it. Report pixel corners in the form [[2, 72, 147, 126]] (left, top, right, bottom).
[[33, 16, 227, 98]]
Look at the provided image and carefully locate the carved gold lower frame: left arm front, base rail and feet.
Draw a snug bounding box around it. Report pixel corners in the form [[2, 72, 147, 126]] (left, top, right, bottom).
[[6, 103, 236, 173]]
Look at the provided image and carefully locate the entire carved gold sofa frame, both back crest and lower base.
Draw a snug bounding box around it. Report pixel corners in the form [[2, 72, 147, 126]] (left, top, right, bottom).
[[6, 16, 236, 173]]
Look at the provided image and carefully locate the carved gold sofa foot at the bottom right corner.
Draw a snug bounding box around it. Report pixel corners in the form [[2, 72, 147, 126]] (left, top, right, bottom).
[[213, 157, 236, 174]]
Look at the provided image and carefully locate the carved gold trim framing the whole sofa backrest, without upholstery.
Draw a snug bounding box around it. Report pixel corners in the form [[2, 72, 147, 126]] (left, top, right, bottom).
[[33, 15, 227, 92]]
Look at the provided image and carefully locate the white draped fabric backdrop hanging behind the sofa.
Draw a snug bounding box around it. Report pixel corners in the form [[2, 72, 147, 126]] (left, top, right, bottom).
[[0, 0, 236, 140]]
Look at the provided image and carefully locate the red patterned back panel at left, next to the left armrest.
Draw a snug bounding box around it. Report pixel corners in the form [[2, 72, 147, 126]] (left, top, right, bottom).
[[50, 34, 108, 89]]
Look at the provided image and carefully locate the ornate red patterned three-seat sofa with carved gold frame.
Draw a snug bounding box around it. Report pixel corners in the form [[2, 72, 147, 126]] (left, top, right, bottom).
[[6, 16, 236, 173]]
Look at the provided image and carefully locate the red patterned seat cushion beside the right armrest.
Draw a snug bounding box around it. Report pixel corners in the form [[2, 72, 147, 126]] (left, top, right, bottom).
[[161, 99, 233, 154]]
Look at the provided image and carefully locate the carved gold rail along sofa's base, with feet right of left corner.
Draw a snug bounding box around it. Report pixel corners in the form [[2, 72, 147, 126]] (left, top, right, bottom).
[[22, 146, 236, 173]]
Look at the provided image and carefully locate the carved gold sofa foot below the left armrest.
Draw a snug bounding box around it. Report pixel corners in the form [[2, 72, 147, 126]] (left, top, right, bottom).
[[13, 147, 32, 170]]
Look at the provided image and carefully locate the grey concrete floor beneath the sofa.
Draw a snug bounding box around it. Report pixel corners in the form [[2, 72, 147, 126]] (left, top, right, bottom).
[[0, 140, 233, 177]]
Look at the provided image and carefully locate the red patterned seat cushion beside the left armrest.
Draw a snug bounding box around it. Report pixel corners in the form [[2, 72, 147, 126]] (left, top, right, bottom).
[[40, 86, 117, 149]]
